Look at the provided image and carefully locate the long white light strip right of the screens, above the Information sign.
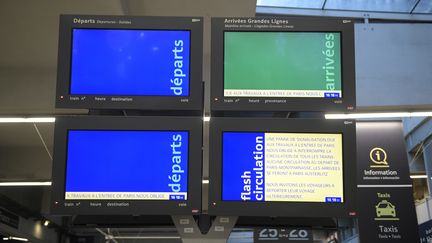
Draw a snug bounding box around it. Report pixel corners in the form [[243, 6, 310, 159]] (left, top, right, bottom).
[[325, 112, 432, 119]]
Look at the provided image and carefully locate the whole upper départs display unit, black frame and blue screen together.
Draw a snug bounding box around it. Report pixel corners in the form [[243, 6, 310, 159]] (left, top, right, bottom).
[[56, 15, 203, 111]]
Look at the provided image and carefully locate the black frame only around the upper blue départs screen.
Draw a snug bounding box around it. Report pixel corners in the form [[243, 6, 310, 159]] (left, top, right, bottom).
[[55, 15, 203, 111]]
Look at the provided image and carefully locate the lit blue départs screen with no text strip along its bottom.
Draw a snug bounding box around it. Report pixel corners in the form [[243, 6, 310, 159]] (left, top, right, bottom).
[[70, 29, 190, 96]]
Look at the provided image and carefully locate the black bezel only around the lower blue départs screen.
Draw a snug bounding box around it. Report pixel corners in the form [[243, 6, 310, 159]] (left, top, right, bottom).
[[51, 116, 202, 215]]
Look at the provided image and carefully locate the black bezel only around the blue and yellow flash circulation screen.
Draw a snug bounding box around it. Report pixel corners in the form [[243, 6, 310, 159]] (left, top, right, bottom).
[[208, 118, 356, 217]]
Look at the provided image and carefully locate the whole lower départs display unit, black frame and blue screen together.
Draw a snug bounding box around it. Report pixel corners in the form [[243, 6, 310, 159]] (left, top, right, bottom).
[[51, 116, 202, 215]]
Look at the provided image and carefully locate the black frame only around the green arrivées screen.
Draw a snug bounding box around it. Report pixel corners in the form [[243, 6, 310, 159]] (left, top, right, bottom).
[[211, 17, 356, 111]]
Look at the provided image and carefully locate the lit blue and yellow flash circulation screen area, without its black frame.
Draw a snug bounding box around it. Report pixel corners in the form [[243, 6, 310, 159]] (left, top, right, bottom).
[[222, 132, 344, 203]]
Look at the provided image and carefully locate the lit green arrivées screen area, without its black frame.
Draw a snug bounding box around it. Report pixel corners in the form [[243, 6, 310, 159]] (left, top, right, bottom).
[[224, 31, 342, 98]]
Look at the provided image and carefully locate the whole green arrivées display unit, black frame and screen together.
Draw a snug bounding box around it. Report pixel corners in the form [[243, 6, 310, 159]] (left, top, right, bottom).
[[211, 17, 355, 111]]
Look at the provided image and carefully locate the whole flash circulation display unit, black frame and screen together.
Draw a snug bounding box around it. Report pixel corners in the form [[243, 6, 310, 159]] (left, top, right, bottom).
[[209, 118, 356, 217]]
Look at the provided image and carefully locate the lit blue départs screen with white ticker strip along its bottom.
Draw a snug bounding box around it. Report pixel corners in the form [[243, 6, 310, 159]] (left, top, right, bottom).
[[65, 130, 189, 200]]
